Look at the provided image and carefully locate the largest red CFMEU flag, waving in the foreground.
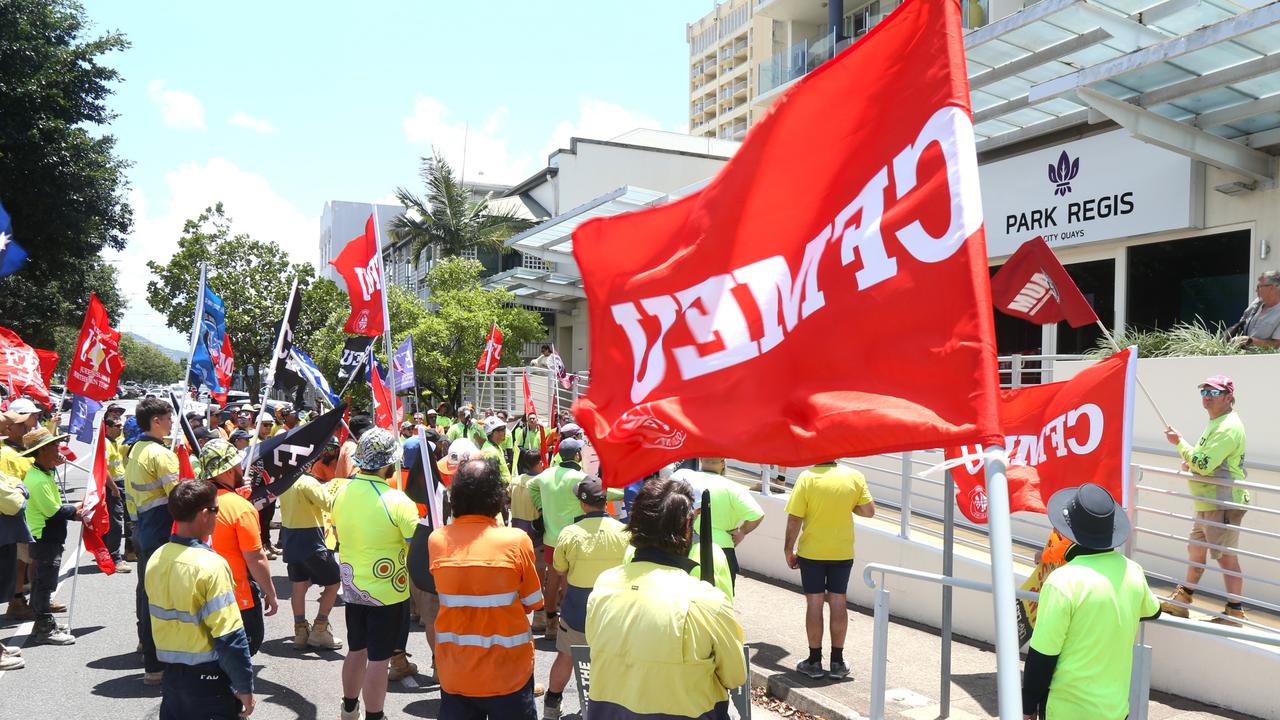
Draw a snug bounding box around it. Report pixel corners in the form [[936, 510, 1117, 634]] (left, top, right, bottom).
[[573, 0, 1000, 486]]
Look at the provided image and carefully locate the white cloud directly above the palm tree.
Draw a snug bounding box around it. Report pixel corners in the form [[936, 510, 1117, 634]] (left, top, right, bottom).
[[404, 96, 534, 184]]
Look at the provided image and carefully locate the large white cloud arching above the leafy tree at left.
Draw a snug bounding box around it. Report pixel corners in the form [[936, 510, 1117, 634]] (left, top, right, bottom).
[[109, 158, 320, 348]]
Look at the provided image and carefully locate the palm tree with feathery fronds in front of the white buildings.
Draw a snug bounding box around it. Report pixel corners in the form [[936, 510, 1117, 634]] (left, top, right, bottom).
[[392, 152, 534, 269]]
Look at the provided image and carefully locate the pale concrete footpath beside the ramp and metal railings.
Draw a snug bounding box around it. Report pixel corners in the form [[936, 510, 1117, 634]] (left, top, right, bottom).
[[735, 574, 1252, 720]]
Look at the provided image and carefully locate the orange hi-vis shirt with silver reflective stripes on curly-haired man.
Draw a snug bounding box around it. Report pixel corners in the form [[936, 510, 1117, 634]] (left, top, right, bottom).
[[429, 515, 543, 697]]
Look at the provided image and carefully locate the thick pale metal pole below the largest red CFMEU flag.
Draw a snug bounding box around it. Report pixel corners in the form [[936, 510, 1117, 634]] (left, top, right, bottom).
[[983, 445, 1023, 720]]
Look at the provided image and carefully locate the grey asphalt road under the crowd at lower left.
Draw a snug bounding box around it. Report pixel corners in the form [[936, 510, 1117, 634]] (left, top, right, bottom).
[[0, 430, 580, 720]]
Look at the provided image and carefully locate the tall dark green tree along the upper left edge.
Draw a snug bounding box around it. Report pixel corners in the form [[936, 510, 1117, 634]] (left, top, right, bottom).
[[0, 0, 133, 347]]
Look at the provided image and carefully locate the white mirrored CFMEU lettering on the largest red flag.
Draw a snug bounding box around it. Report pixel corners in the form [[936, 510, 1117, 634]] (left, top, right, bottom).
[[609, 106, 982, 404]]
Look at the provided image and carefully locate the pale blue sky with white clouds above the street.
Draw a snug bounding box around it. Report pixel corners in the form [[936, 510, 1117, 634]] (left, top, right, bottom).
[[86, 0, 713, 347]]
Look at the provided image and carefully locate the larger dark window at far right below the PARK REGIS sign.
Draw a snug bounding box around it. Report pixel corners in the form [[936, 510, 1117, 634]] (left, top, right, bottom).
[[1125, 231, 1252, 329]]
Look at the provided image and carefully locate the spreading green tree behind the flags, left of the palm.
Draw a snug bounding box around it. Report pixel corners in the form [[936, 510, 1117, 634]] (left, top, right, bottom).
[[147, 202, 314, 402]]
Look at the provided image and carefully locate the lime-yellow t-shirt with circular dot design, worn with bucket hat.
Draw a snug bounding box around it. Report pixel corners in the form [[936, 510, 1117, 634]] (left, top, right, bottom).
[[333, 473, 417, 605]]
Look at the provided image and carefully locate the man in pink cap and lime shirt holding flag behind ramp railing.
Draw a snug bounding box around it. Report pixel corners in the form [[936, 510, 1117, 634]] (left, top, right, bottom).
[[1161, 375, 1249, 628]]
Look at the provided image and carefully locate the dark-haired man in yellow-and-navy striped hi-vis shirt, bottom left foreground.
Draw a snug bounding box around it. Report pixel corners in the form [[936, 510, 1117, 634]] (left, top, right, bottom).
[[145, 480, 253, 720]]
